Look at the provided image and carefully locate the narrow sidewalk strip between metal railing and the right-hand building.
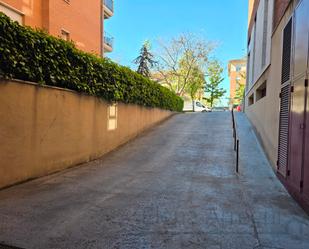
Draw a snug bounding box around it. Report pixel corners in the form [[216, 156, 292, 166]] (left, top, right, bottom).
[[236, 113, 309, 249]]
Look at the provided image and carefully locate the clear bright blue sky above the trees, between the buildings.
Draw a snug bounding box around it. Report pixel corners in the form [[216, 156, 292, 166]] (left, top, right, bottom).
[[104, 0, 248, 105]]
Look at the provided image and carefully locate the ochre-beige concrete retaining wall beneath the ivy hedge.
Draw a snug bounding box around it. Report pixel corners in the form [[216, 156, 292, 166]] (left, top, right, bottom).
[[0, 81, 173, 188]]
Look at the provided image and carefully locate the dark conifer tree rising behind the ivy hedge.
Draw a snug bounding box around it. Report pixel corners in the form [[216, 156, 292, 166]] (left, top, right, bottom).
[[133, 41, 156, 78]]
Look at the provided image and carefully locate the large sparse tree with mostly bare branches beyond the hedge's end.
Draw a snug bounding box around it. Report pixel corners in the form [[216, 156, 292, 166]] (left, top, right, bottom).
[[157, 34, 215, 96]]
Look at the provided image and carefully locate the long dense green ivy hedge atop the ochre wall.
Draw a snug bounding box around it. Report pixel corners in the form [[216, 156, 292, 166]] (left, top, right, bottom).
[[0, 13, 183, 111]]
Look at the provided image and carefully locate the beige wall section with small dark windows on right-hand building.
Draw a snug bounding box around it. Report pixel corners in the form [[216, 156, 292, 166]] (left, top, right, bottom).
[[245, 2, 293, 168]]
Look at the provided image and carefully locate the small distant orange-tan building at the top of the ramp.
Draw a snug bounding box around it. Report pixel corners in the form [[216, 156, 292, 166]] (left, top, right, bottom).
[[228, 59, 246, 104]]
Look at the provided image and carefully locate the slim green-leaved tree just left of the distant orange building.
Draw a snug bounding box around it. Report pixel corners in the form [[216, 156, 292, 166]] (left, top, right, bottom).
[[204, 60, 226, 107]]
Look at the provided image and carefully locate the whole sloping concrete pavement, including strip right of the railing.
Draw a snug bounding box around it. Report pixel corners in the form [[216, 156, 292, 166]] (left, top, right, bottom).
[[0, 112, 309, 249]]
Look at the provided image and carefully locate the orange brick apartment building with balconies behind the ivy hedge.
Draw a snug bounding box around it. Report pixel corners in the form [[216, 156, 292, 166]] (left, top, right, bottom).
[[0, 0, 114, 56]]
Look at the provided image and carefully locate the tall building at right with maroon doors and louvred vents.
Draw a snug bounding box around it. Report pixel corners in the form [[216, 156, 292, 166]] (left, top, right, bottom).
[[245, 0, 309, 211]]
